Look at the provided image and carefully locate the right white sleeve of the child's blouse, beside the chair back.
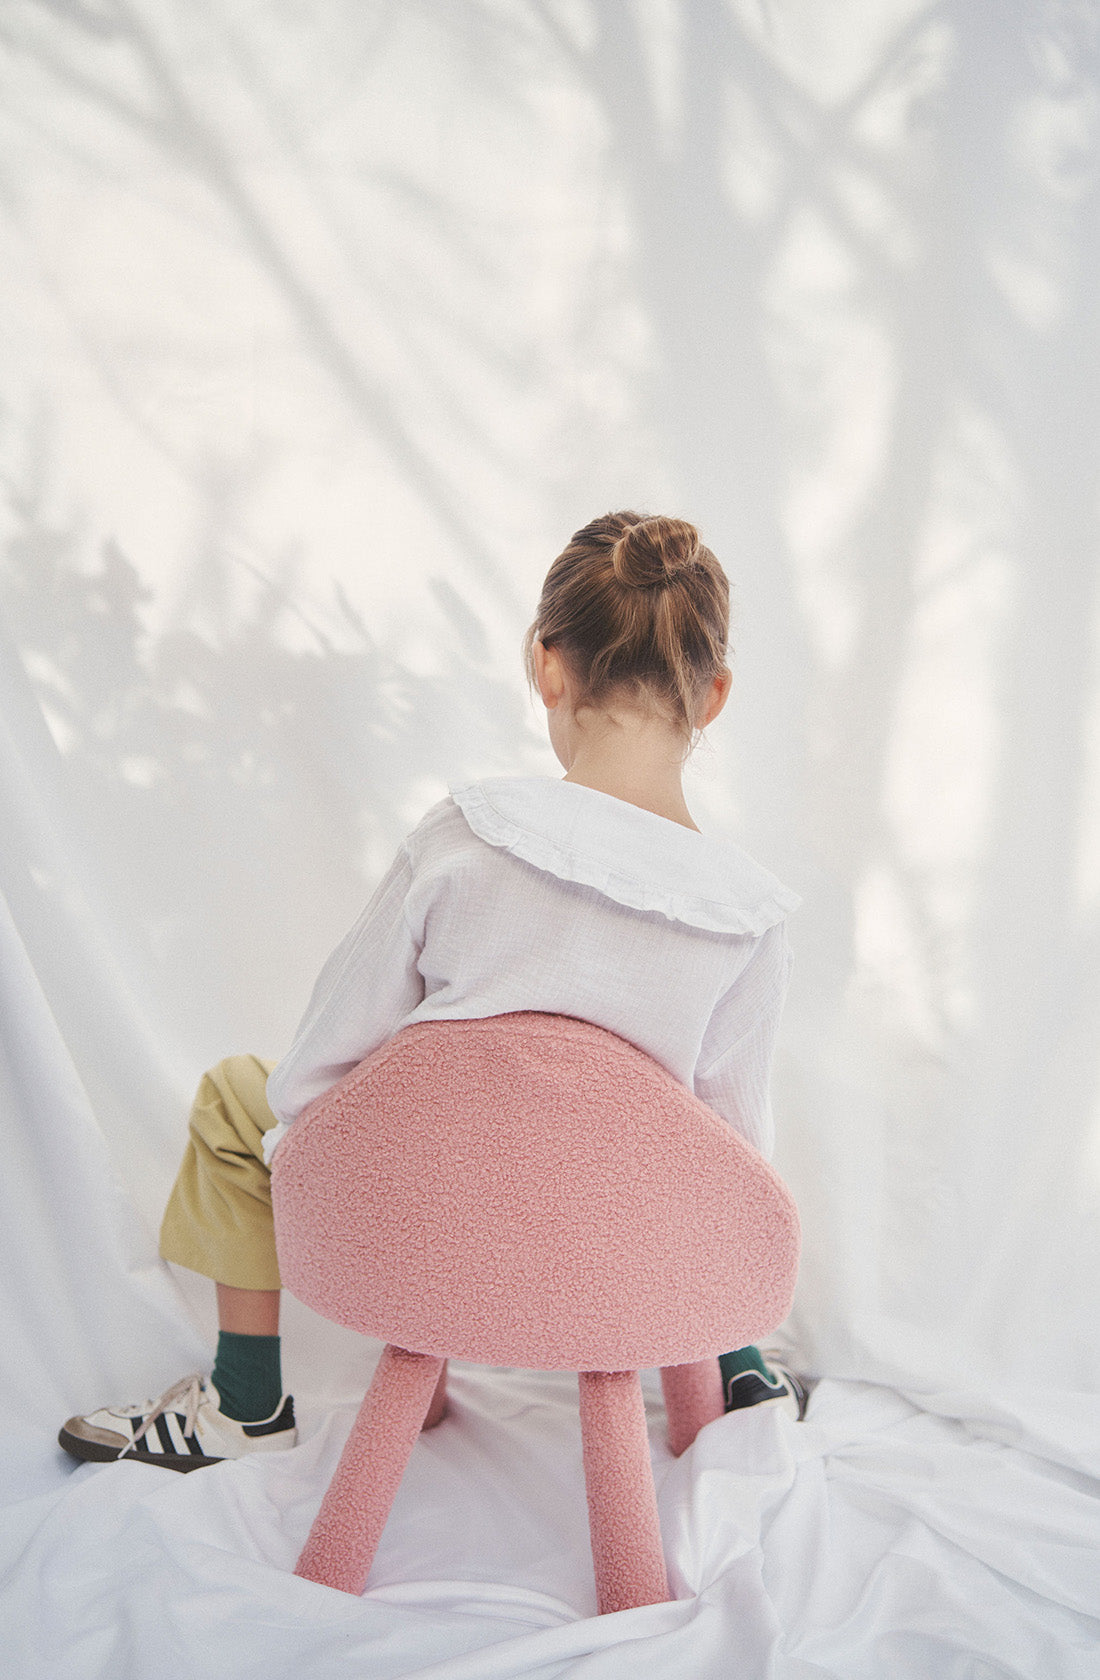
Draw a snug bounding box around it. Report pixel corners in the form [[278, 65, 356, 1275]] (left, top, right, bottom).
[[695, 922, 791, 1156]]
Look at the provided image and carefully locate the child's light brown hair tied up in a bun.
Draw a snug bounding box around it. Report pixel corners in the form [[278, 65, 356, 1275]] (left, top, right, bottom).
[[524, 512, 729, 739]]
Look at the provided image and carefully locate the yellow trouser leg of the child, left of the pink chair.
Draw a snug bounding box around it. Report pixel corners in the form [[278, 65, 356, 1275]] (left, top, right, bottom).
[[160, 1055, 280, 1289]]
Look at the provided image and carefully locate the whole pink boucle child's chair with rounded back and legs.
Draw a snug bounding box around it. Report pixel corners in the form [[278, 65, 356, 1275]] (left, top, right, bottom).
[[272, 1013, 799, 1613]]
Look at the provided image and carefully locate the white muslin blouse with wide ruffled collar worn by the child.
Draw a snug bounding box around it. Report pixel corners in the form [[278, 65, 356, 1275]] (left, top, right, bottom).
[[264, 776, 799, 1161]]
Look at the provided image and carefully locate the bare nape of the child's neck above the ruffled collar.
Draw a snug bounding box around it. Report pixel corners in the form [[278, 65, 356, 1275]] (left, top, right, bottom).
[[564, 716, 699, 832]]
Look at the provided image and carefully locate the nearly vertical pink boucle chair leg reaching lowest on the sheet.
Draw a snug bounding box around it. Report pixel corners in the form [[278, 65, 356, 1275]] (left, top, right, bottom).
[[579, 1371, 668, 1616]]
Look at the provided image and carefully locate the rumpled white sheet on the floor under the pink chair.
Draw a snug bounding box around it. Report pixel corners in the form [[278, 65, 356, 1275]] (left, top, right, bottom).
[[0, 1368, 1100, 1680]]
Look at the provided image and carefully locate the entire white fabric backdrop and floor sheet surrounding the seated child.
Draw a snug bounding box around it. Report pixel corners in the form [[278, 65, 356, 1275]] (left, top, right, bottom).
[[0, 0, 1100, 1680]]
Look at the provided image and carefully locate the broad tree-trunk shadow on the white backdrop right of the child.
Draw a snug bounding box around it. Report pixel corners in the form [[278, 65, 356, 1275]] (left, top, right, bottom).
[[567, 0, 1100, 1364]]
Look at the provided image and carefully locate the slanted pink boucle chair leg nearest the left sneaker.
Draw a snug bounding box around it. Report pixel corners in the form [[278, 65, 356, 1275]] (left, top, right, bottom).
[[294, 1347, 443, 1593]]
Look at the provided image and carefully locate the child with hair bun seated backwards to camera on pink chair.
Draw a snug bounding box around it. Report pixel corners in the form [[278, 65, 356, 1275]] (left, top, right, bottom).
[[59, 512, 804, 1470]]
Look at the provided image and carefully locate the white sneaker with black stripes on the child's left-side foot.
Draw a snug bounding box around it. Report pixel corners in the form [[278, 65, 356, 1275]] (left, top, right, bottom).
[[57, 1376, 297, 1470]]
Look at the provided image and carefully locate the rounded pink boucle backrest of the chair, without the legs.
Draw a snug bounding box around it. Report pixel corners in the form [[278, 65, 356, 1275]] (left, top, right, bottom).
[[272, 1013, 799, 1371]]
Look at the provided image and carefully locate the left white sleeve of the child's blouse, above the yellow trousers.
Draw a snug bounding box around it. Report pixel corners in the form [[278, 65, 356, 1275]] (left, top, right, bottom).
[[264, 847, 423, 1161]]
